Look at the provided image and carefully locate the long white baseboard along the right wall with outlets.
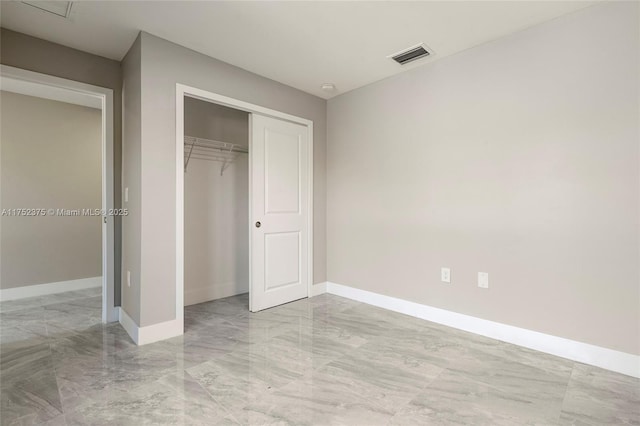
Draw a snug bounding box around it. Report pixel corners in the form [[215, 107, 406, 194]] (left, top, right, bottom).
[[326, 282, 640, 377]]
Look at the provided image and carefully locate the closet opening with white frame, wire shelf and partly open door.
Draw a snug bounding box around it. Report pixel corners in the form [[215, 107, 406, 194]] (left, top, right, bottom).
[[176, 84, 313, 326]]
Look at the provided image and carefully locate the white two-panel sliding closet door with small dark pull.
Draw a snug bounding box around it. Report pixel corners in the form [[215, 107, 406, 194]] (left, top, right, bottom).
[[249, 114, 310, 312]]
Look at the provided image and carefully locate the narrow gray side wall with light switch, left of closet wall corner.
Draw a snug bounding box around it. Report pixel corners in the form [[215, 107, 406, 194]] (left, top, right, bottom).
[[122, 37, 142, 324]]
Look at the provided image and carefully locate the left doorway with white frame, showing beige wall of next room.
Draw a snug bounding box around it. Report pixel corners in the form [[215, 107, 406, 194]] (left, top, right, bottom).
[[0, 65, 118, 322]]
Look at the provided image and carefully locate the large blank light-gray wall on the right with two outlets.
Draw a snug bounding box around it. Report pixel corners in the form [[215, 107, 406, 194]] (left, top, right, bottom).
[[327, 2, 640, 354]]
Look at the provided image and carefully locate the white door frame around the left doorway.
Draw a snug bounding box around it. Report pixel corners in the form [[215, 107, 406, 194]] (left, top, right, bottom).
[[0, 65, 119, 323]]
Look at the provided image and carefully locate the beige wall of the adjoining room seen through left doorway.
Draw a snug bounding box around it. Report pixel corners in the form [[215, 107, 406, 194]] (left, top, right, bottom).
[[0, 91, 102, 288]]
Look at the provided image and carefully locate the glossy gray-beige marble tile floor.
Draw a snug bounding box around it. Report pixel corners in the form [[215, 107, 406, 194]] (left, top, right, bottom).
[[0, 294, 640, 426]]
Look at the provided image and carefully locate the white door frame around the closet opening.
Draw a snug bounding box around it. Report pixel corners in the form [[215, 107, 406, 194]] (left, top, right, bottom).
[[176, 83, 313, 319]]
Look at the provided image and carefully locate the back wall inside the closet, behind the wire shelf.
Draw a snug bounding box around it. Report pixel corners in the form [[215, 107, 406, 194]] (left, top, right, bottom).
[[184, 98, 249, 305]]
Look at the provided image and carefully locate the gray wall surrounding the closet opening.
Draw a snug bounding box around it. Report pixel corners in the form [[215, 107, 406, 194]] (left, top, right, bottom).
[[124, 33, 326, 326]]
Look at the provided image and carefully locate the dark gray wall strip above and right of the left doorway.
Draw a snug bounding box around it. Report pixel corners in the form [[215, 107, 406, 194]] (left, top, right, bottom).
[[0, 28, 122, 306]]
